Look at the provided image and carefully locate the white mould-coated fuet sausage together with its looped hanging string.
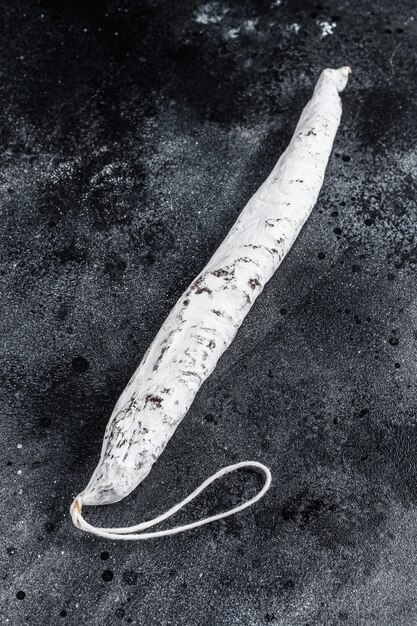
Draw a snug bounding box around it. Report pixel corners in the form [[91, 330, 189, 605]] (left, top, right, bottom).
[[71, 67, 350, 540]]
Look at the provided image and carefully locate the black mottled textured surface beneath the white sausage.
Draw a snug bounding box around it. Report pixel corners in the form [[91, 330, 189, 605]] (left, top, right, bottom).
[[0, 0, 417, 626]]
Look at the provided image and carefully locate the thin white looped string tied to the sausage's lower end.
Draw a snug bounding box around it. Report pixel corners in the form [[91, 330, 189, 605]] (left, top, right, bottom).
[[71, 461, 272, 541]]
